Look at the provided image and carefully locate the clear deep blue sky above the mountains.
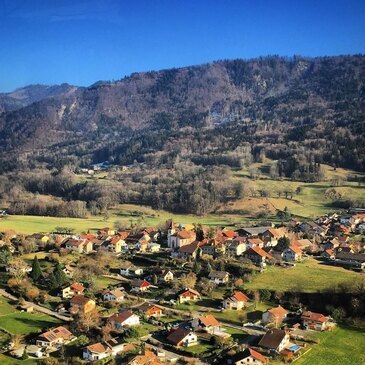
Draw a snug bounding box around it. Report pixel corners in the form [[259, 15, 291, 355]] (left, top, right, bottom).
[[0, 0, 365, 91]]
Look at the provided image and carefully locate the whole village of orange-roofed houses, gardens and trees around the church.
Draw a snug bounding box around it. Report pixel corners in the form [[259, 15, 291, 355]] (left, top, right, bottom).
[[0, 208, 365, 365]]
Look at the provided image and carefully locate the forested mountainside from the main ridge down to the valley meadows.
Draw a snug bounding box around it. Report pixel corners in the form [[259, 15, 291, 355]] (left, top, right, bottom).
[[0, 55, 365, 213]]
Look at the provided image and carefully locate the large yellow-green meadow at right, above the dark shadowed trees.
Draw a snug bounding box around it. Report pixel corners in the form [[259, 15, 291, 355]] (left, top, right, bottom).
[[245, 258, 364, 293]]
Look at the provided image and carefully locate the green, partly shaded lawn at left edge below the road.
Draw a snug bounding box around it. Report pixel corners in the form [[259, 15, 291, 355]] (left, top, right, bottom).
[[0, 297, 59, 335]]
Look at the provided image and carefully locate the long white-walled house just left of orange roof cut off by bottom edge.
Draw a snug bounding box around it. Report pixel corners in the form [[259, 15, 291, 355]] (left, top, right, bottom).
[[82, 337, 134, 361]]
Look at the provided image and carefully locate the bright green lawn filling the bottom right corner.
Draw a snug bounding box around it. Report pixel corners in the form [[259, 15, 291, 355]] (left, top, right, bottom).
[[296, 327, 365, 365]]
